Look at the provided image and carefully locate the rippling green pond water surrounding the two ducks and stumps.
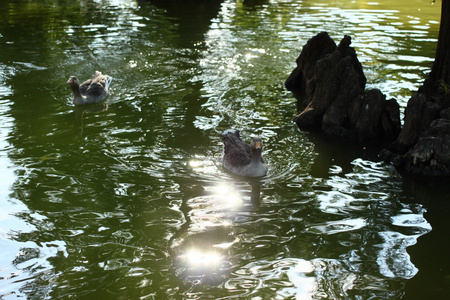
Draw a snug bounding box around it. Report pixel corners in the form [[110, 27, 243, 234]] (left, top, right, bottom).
[[0, 0, 450, 299]]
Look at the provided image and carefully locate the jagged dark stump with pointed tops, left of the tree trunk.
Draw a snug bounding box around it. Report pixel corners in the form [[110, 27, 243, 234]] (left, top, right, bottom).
[[285, 32, 400, 143]]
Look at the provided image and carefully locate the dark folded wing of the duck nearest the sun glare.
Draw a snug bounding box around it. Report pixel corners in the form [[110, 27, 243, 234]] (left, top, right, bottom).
[[221, 130, 252, 167]]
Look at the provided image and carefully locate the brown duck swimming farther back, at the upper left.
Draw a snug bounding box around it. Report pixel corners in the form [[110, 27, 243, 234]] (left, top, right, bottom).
[[67, 71, 112, 105]]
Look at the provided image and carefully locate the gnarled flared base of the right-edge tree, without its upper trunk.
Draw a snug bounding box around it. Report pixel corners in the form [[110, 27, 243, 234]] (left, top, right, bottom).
[[380, 83, 450, 177]]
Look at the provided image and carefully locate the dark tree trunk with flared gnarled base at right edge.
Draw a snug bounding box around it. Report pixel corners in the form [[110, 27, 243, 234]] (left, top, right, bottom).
[[380, 1, 450, 178]]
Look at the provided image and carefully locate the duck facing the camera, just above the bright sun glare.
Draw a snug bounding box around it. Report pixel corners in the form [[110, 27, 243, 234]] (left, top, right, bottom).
[[221, 129, 269, 177]]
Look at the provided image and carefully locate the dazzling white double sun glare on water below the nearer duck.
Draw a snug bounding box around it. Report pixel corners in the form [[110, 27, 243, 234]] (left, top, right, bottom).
[[171, 183, 242, 285]]
